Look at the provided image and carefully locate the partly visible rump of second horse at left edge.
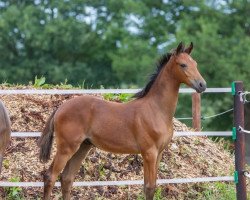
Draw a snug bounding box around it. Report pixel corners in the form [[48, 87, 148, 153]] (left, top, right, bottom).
[[0, 101, 11, 174]]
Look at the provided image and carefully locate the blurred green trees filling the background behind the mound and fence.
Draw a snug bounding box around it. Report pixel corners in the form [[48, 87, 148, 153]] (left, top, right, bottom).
[[0, 0, 250, 130]]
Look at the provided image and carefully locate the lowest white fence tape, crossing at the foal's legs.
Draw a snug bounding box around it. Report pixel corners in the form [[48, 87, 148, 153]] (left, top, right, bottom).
[[0, 176, 234, 187]]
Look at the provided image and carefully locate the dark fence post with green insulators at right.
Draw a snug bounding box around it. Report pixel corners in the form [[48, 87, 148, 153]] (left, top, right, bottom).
[[233, 81, 247, 200]]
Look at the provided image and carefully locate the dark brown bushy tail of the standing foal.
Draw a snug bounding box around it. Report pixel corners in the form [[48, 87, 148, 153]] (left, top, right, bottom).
[[38, 110, 56, 162]]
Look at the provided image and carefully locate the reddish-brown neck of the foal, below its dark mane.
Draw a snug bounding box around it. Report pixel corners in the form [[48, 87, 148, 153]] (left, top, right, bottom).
[[148, 61, 180, 121]]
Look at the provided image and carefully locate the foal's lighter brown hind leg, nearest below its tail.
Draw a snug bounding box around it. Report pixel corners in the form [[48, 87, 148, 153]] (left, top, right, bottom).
[[43, 142, 80, 200]]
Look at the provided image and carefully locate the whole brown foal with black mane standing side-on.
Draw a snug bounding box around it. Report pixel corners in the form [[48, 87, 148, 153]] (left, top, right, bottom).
[[40, 43, 206, 200]]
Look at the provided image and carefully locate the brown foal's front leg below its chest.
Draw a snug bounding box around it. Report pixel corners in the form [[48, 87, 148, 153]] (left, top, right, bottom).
[[142, 150, 158, 200]]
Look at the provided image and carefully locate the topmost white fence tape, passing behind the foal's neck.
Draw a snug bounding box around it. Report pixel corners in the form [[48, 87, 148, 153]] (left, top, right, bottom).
[[0, 88, 231, 95]]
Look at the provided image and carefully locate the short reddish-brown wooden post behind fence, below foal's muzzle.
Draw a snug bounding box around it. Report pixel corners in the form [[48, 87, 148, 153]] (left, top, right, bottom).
[[192, 93, 201, 131]]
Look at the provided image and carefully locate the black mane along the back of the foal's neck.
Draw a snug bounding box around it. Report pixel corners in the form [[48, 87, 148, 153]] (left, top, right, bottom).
[[134, 53, 172, 99]]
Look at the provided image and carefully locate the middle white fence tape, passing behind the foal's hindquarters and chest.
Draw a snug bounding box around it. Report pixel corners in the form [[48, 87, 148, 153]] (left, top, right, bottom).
[[11, 131, 232, 137]]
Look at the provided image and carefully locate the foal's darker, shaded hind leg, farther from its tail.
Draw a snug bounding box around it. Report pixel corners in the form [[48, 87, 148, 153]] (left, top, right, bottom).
[[61, 141, 93, 200]]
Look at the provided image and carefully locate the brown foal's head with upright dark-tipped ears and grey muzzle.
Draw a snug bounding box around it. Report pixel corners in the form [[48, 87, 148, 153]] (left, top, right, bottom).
[[170, 42, 206, 93]]
